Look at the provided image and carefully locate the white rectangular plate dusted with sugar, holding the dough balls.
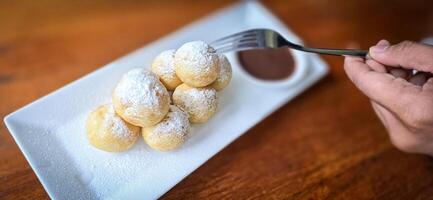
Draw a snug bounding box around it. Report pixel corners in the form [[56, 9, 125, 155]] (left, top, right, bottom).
[[5, 2, 327, 199]]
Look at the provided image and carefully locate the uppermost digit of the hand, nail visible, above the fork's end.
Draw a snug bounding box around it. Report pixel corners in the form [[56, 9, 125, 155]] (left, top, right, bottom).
[[369, 40, 433, 72]]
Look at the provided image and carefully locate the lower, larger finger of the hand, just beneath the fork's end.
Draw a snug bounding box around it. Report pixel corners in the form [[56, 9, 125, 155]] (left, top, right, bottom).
[[344, 57, 422, 116]]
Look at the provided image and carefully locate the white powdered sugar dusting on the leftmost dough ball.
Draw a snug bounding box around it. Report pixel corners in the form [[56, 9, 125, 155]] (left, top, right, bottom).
[[102, 104, 135, 141]]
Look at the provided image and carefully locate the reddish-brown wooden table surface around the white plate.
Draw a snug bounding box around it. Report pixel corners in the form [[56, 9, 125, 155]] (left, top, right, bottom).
[[0, 0, 433, 199]]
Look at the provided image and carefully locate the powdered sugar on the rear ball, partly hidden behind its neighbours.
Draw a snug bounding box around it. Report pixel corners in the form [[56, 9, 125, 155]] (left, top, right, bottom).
[[152, 49, 176, 78]]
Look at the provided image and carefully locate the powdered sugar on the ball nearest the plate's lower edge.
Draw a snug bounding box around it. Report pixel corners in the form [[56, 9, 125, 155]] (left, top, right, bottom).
[[152, 105, 190, 137]]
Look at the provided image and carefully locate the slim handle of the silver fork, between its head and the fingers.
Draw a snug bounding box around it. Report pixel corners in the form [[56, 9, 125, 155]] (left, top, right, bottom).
[[291, 45, 368, 58]]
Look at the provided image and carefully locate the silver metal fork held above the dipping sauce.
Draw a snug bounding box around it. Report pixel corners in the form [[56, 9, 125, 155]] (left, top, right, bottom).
[[210, 29, 368, 57]]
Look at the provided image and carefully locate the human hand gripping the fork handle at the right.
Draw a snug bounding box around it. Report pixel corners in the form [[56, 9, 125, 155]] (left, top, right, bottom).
[[344, 40, 433, 156]]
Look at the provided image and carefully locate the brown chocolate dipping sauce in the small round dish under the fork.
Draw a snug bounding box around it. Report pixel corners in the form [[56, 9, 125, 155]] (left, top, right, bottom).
[[238, 48, 295, 80]]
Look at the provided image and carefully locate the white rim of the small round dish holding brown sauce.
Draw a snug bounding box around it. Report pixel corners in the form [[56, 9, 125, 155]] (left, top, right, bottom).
[[229, 49, 308, 87]]
